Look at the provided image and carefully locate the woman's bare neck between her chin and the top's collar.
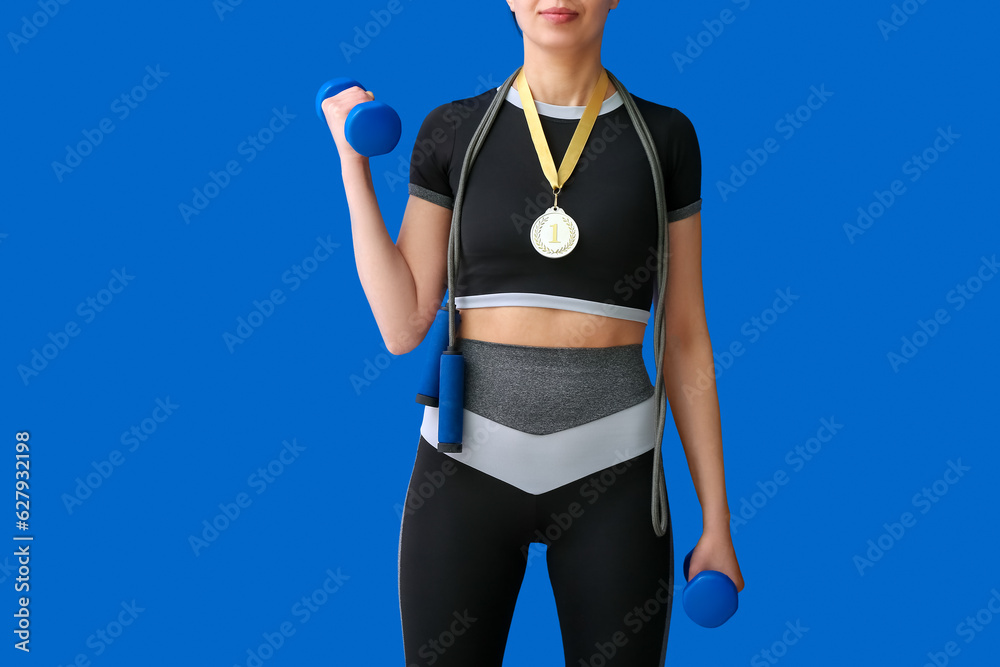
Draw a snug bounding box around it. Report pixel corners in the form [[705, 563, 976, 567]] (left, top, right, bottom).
[[514, 45, 615, 107]]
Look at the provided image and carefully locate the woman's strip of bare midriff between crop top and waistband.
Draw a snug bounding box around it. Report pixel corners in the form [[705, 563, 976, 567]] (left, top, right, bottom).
[[458, 306, 646, 347]]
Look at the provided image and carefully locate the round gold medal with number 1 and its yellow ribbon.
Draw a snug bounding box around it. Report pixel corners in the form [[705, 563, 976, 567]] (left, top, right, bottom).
[[517, 67, 608, 258]]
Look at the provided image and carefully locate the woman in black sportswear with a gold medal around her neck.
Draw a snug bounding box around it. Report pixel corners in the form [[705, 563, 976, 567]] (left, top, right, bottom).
[[323, 0, 743, 667]]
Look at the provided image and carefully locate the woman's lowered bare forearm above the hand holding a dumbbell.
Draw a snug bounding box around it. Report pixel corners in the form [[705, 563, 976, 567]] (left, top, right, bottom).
[[663, 331, 730, 532]]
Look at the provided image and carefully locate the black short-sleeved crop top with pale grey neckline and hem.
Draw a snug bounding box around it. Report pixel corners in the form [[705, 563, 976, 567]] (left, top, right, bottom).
[[409, 86, 701, 323]]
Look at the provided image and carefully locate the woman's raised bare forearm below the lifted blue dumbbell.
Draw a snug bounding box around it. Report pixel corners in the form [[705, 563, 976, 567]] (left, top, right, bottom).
[[341, 157, 423, 354]]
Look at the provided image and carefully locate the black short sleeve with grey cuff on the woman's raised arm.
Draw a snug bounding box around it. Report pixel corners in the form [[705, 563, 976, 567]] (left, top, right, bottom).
[[409, 103, 455, 208]]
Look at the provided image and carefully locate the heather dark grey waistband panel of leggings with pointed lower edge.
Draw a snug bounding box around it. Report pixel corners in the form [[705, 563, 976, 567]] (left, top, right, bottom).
[[458, 338, 653, 435]]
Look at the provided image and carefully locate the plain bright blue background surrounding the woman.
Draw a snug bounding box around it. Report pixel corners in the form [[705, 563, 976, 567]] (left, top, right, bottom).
[[0, 0, 1000, 667]]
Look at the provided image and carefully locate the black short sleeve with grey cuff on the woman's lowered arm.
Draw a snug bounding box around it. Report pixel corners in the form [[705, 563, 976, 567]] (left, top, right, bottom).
[[663, 109, 701, 222]]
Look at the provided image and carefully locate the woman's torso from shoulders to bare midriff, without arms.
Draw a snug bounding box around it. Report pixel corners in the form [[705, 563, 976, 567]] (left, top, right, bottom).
[[424, 81, 688, 347]]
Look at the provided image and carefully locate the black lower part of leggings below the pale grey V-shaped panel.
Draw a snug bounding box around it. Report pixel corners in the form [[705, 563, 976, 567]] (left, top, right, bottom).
[[399, 436, 673, 667]]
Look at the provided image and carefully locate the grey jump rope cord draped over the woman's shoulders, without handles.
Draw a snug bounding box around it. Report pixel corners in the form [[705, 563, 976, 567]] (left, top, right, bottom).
[[448, 67, 672, 537]]
